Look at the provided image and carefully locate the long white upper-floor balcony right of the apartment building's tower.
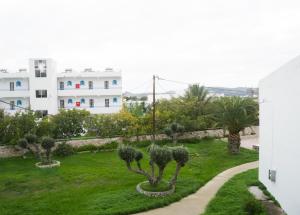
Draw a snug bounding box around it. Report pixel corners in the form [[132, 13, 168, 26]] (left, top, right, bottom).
[[57, 87, 122, 96]]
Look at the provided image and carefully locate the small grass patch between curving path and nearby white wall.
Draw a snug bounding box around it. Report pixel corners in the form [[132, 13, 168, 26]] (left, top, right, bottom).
[[204, 169, 267, 215]]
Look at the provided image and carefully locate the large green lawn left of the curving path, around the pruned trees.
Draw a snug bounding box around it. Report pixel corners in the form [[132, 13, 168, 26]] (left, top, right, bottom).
[[0, 140, 258, 215]]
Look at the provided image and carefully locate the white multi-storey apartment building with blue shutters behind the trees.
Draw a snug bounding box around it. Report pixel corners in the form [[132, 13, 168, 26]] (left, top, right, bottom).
[[0, 59, 122, 115]]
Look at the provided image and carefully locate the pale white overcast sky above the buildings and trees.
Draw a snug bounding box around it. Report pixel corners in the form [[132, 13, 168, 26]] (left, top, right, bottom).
[[0, 0, 300, 91]]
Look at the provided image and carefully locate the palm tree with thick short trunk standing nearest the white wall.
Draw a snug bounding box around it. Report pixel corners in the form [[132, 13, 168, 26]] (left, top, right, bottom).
[[216, 96, 258, 154]]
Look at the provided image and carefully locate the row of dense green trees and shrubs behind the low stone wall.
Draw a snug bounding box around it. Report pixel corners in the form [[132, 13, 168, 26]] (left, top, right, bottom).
[[0, 85, 258, 154]]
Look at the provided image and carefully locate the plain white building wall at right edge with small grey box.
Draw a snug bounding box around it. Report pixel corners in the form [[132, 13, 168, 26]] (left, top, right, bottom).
[[259, 57, 300, 215]]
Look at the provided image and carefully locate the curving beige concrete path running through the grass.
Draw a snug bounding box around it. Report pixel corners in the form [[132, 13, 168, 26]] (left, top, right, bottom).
[[136, 161, 258, 215]]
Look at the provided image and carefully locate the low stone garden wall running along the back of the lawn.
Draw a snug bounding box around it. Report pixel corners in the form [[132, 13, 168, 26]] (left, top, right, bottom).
[[0, 126, 259, 158]]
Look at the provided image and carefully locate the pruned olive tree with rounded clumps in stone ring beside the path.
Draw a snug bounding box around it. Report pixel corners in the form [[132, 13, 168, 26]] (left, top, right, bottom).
[[118, 144, 189, 186]]
